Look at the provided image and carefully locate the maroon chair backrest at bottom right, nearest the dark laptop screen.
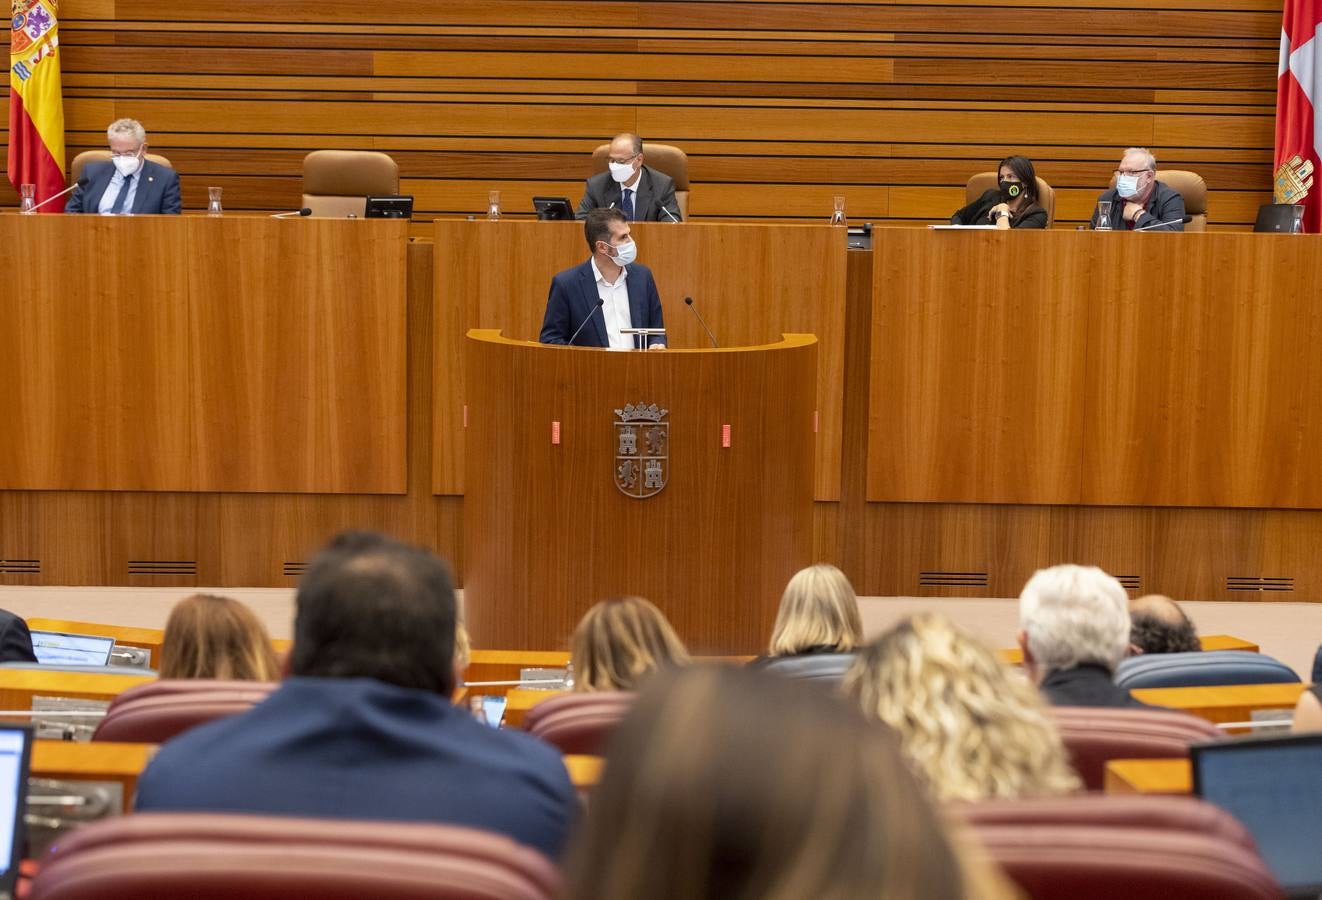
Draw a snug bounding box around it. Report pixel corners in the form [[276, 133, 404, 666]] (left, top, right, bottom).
[[974, 825, 1281, 900]]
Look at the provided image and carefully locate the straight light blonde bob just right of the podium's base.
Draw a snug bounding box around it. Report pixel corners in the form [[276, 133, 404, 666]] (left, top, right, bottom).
[[769, 563, 863, 657]]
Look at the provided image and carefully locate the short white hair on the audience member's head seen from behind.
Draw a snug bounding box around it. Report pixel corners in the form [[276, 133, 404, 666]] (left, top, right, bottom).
[[1019, 566, 1129, 673]]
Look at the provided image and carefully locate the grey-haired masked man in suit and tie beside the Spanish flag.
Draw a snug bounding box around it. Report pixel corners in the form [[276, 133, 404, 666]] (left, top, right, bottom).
[[65, 119, 184, 215]]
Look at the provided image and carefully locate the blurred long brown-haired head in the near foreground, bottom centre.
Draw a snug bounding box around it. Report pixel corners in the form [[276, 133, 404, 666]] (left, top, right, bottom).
[[564, 666, 998, 900]]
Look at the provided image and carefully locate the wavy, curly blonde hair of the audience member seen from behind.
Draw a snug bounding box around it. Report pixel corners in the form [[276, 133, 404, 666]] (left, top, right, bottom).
[[842, 613, 1080, 801]]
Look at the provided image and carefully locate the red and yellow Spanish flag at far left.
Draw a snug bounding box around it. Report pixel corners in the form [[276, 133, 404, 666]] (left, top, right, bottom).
[[9, 0, 65, 211]]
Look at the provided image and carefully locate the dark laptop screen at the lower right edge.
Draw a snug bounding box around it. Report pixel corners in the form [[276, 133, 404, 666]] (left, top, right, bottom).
[[1190, 733, 1322, 897]]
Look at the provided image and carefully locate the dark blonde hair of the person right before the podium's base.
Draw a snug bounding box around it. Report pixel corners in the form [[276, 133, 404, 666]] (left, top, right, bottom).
[[570, 597, 689, 691]]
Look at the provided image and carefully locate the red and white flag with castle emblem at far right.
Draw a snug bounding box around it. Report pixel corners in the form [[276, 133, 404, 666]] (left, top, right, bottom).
[[1273, 0, 1322, 234]]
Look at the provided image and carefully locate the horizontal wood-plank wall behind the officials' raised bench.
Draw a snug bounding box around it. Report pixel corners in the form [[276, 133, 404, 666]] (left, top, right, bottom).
[[0, 0, 1281, 229]]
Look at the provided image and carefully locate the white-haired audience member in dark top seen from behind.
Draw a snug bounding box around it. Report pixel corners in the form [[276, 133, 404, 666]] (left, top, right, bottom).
[[1019, 566, 1147, 707]]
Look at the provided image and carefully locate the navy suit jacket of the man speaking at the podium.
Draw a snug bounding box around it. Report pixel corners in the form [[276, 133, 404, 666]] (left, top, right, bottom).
[[541, 259, 665, 346]]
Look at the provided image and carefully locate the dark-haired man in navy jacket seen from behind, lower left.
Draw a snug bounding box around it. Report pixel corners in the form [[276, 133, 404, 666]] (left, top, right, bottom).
[[137, 531, 578, 858]]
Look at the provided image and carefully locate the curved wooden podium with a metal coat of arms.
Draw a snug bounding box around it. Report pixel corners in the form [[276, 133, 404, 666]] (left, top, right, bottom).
[[464, 329, 817, 654]]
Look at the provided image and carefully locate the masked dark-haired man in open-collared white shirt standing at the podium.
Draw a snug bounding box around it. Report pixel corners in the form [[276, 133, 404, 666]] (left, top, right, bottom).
[[541, 209, 665, 350]]
